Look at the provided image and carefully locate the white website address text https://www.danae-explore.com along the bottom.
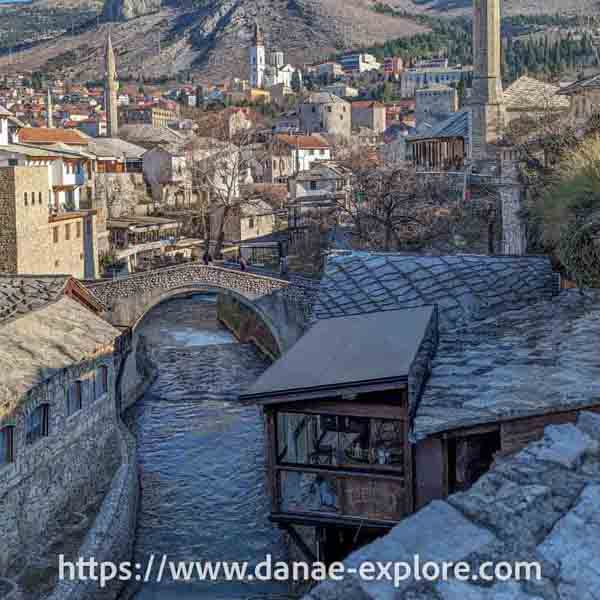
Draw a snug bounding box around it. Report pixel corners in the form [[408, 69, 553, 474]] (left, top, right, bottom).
[[59, 554, 542, 588]]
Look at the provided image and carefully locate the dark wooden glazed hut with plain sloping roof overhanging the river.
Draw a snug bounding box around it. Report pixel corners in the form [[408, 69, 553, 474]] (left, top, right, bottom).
[[243, 307, 437, 560]]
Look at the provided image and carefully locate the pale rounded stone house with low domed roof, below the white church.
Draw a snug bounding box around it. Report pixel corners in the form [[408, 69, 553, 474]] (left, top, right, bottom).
[[299, 92, 352, 138]]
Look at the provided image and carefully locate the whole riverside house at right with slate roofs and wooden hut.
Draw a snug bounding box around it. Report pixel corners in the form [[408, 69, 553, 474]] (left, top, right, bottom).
[[243, 253, 600, 561]]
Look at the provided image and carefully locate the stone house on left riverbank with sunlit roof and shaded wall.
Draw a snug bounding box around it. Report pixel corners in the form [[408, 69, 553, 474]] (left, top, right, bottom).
[[0, 275, 135, 597]]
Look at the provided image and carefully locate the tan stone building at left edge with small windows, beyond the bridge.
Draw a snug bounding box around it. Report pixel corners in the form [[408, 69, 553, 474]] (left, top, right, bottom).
[[0, 165, 98, 279]]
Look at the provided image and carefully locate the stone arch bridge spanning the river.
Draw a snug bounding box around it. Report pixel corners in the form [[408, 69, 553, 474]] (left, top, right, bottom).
[[86, 263, 317, 356]]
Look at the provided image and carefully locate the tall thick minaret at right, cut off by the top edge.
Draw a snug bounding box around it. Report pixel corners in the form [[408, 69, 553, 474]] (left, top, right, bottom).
[[470, 0, 504, 160]]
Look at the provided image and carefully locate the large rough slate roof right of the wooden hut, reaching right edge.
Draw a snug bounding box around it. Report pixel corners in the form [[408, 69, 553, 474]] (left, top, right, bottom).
[[414, 290, 600, 439]]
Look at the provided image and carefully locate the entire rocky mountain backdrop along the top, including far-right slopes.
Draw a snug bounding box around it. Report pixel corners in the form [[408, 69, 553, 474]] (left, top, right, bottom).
[[0, 0, 598, 82]]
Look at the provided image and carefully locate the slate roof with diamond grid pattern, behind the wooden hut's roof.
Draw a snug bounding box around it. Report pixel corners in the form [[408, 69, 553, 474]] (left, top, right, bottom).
[[314, 252, 557, 330]]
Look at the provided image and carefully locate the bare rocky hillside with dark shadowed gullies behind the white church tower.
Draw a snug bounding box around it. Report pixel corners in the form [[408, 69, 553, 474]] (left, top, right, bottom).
[[0, 0, 424, 81]]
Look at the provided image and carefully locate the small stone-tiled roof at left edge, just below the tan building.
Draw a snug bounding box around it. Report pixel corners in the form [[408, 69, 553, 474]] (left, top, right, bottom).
[[0, 274, 70, 326]]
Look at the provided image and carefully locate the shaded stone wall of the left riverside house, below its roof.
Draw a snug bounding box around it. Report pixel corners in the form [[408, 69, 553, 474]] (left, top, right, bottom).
[[0, 355, 121, 593]]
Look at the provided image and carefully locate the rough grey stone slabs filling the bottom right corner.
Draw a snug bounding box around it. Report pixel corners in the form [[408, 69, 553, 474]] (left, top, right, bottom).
[[305, 413, 600, 600]]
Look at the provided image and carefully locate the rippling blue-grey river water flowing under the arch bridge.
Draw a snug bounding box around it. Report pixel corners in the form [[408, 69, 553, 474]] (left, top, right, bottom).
[[127, 295, 291, 600]]
